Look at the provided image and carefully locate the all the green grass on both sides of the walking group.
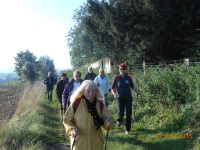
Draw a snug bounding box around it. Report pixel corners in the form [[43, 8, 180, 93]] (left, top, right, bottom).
[[0, 82, 200, 150]]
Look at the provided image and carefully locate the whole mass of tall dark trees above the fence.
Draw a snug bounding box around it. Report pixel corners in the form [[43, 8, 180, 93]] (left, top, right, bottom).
[[69, 0, 200, 66]]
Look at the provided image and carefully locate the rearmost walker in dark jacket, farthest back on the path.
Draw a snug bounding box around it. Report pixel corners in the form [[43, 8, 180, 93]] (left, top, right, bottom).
[[43, 71, 57, 102]]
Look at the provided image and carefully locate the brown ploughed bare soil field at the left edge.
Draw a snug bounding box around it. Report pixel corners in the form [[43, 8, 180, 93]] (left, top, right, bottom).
[[0, 86, 23, 122]]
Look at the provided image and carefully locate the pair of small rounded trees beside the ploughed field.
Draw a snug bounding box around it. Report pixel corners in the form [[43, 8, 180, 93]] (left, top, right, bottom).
[[15, 50, 56, 83]]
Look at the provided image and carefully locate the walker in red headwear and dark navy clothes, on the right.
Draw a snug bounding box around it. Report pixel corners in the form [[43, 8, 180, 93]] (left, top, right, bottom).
[[111, 64, 141, 134]]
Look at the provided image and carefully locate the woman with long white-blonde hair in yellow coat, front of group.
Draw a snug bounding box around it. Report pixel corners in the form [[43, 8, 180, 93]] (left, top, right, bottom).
[[63, 80, 113, 150]]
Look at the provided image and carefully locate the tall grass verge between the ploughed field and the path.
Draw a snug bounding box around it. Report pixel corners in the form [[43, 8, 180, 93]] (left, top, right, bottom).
[[0, 84, 59, 149]]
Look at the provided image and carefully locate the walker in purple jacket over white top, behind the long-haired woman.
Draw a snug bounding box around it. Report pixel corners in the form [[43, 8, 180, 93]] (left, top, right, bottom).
[[62, 71, 83, 113]]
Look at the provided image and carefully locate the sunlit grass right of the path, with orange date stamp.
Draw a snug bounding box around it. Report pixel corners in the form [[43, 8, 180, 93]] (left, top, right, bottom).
[[102, 93, 200, 150]]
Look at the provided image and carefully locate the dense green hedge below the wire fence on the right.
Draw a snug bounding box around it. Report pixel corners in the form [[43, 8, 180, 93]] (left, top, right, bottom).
[[136, 65, 200, 126]]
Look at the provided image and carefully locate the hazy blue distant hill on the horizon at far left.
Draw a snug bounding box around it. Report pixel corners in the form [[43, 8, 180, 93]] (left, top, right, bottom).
[[0, 72, 19, 83]]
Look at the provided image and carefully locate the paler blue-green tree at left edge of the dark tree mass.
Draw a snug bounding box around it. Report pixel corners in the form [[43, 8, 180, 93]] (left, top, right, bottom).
[[67, 7, 103, 68]]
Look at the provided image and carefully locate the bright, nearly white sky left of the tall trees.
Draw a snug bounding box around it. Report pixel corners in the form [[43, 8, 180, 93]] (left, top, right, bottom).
[[0, 0, 86, 73]]
